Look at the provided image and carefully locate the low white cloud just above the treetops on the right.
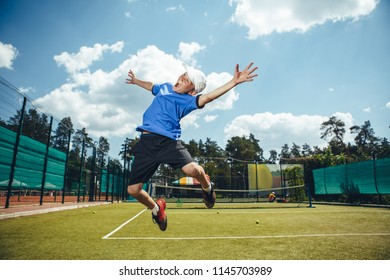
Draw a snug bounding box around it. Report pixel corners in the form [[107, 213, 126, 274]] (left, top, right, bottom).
[[224, 112, 354, 155]]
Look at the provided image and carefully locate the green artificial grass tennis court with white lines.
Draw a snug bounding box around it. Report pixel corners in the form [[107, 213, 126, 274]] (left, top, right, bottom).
[[0, 203, 390, 260]]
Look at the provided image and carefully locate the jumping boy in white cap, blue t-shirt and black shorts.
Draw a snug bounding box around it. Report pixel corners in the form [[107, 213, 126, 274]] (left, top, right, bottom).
[[126, 63, 257, 231]]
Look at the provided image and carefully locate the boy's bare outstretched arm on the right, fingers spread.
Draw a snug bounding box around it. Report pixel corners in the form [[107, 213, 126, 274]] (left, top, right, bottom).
[[198, 62, 258, 107]]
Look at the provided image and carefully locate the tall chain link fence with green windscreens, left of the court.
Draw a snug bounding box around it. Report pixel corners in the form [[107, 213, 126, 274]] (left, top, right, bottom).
[[0, 77, 127, 208]]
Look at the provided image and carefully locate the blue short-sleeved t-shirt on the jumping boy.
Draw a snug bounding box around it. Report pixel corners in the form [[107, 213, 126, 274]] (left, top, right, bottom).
[[137, 83, 200, 140]]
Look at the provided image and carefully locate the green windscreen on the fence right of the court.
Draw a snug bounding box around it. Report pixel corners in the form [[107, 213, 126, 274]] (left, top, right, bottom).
[[313, 158, 390, 195]]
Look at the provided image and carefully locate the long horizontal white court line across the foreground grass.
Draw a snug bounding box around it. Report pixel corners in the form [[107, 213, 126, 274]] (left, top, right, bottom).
[[104, 232, 390, 240]]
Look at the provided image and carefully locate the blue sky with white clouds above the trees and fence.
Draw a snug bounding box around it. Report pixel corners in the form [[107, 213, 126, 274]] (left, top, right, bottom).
[[0, 0, 390, 160]]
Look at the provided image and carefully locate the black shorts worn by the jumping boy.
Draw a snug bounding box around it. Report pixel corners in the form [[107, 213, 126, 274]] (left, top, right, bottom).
[[129, 134, 193, 185]]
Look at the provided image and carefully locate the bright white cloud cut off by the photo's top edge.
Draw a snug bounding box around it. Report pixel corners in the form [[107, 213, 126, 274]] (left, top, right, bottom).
[[230, 0, 379, 39]]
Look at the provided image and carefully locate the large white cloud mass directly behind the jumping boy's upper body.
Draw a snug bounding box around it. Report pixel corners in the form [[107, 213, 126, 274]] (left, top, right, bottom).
[[36, 44, 238, 143]]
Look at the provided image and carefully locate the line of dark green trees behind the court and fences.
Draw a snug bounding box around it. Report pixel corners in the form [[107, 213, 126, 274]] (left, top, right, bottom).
[[0, 109, 390, 201]]
